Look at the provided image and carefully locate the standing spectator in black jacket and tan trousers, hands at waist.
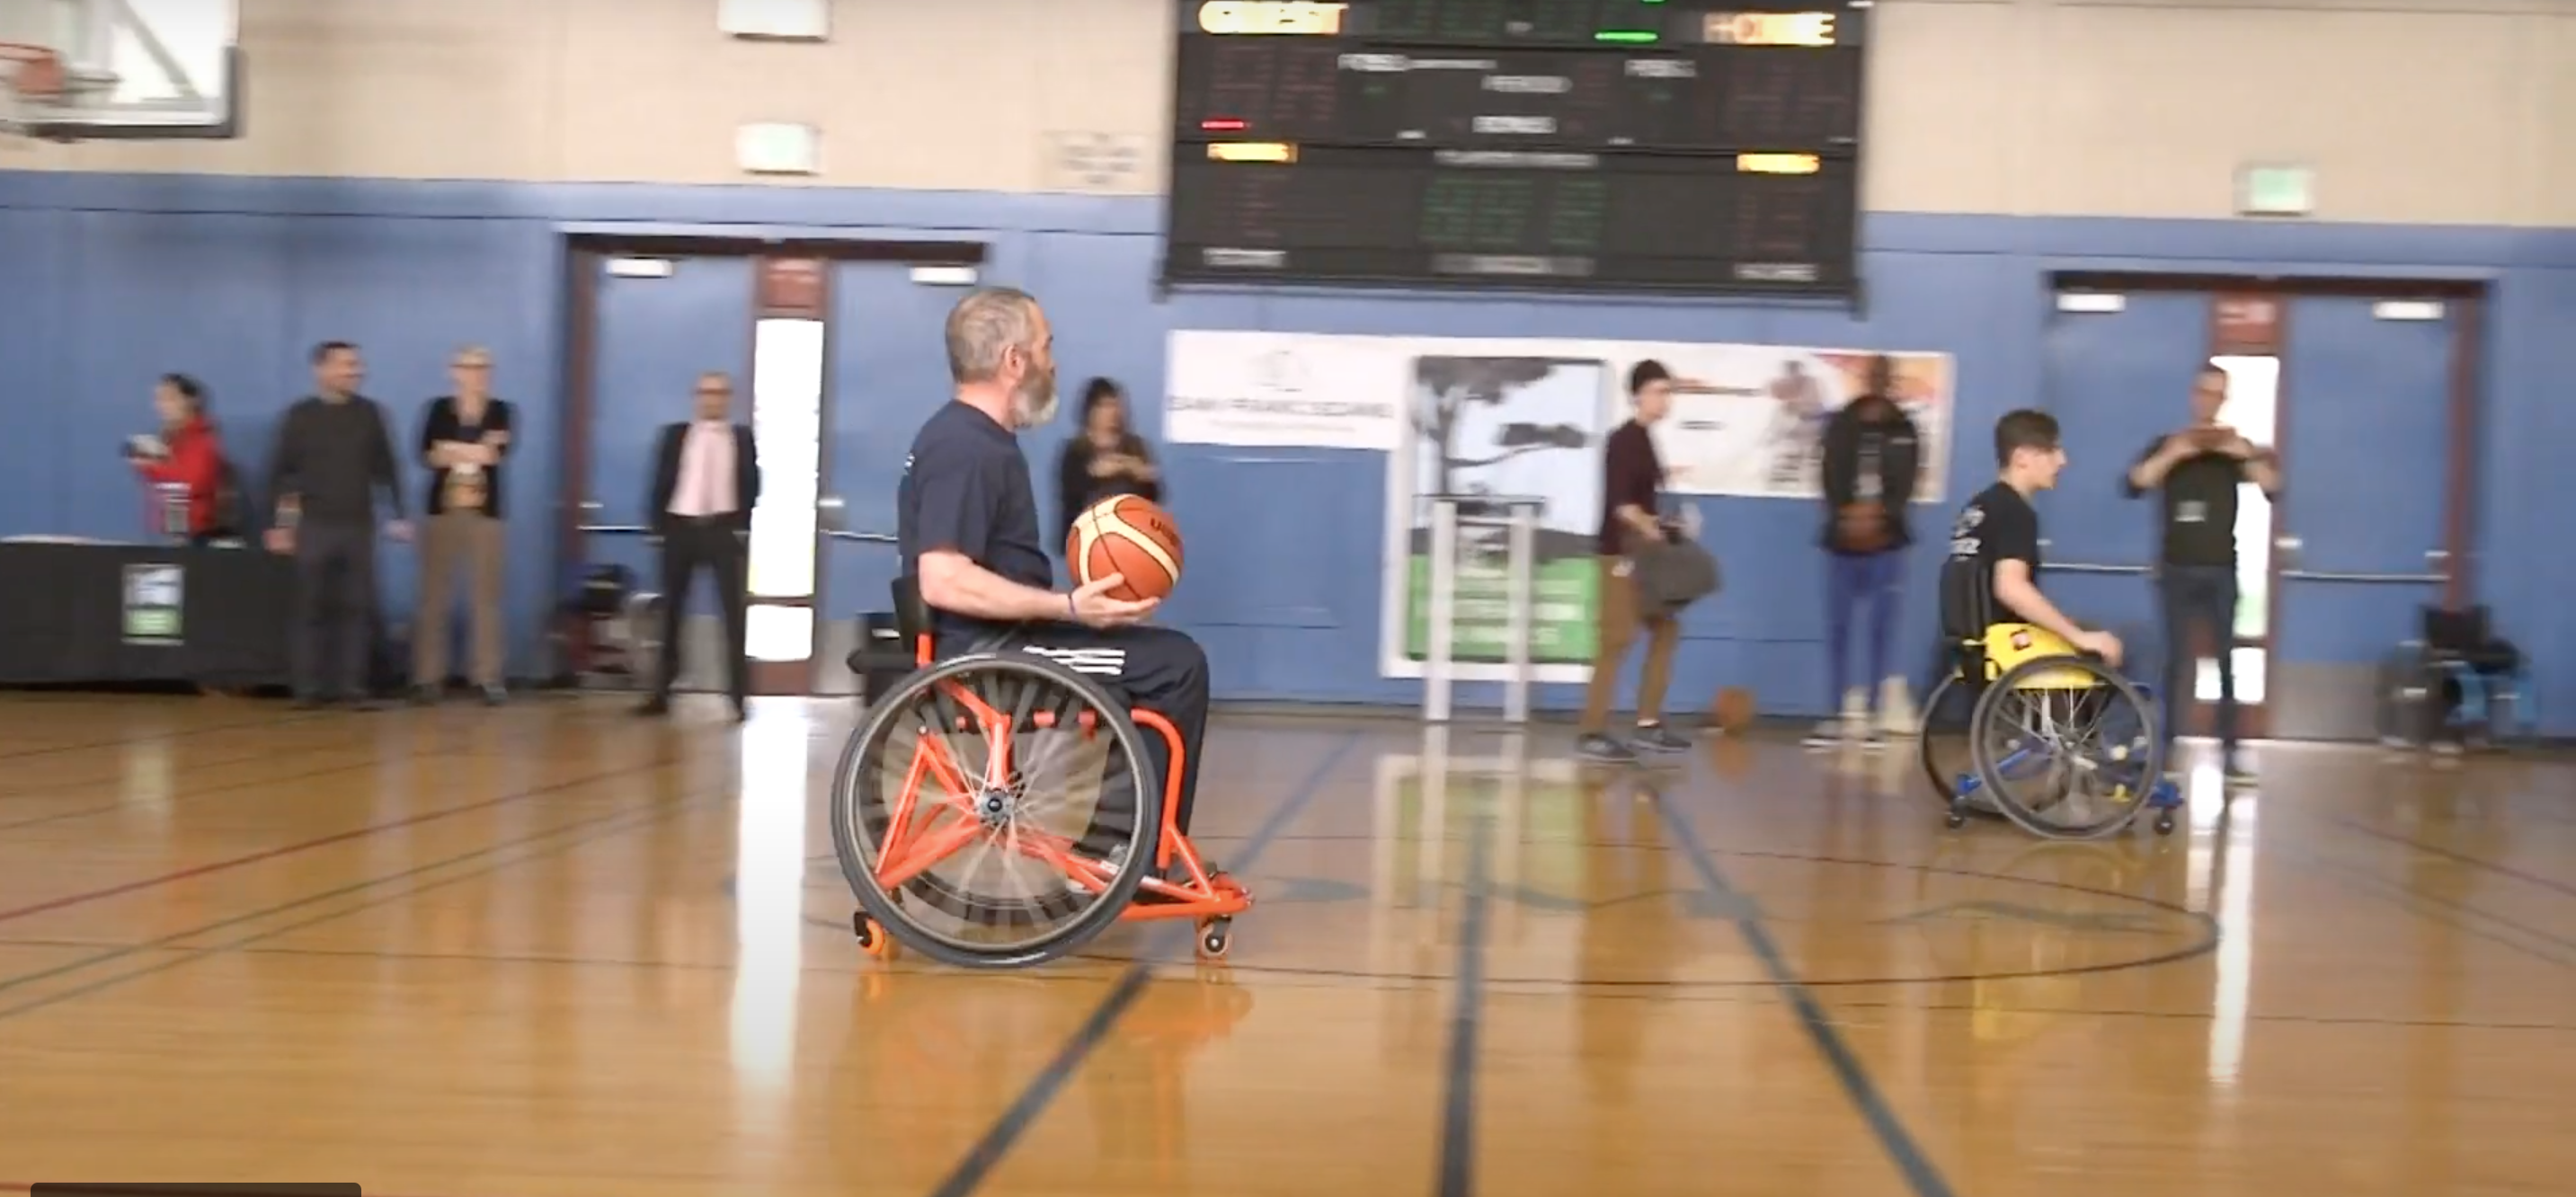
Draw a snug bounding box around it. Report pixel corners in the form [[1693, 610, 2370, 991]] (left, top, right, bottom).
[[413, 348, 512, 705]]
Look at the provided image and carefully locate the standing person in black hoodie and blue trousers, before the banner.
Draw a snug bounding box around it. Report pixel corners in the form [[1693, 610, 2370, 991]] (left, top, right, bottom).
[[1808, 355, 1922, 747]]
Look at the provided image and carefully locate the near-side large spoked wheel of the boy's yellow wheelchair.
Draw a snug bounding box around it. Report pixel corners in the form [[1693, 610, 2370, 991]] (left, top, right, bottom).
[[1968, 656, 2163, 839]]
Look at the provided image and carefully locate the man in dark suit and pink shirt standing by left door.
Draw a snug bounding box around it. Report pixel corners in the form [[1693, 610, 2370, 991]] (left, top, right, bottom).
[[642, 370, 759, 721]]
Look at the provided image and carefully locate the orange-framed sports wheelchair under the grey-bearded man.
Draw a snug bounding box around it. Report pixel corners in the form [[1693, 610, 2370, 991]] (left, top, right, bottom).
[[832, 589, 1252, 968]]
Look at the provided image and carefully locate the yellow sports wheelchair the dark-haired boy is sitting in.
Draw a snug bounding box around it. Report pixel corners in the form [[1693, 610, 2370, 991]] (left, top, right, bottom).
[[1919, 623, 2182, 839]]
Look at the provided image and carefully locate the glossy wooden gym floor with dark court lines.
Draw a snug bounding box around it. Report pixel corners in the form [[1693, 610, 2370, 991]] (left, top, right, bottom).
[[0, 695, 2576, 1197]]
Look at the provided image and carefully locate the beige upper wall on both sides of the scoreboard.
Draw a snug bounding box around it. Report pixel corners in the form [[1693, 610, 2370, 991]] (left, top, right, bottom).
[[0, 0, 2576, 226]]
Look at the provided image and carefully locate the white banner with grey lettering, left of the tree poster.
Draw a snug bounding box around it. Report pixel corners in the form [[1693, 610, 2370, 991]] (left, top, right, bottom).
[[1162, 332, 1407, 450]]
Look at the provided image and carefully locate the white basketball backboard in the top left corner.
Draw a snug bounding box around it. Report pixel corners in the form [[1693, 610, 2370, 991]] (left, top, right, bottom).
[[0, 0, 242, 142]]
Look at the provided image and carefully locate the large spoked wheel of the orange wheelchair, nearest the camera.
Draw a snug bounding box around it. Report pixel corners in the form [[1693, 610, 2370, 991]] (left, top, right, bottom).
[[832, 654, 1162, 968]]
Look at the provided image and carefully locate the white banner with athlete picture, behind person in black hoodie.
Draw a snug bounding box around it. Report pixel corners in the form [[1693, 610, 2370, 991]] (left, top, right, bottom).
[[1621, 345, 1952, 502]]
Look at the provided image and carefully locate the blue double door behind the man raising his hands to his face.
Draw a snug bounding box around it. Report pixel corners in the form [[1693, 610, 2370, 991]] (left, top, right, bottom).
[[2040, 280, 2460, 739]]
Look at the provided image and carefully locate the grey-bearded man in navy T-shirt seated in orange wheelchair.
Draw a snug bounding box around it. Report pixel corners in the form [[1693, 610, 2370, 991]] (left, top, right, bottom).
[[894, 288, 1213, 873]]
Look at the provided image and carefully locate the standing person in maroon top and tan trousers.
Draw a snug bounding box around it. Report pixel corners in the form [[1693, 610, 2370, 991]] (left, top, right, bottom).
[[1574, 360, 1705, 762]]
